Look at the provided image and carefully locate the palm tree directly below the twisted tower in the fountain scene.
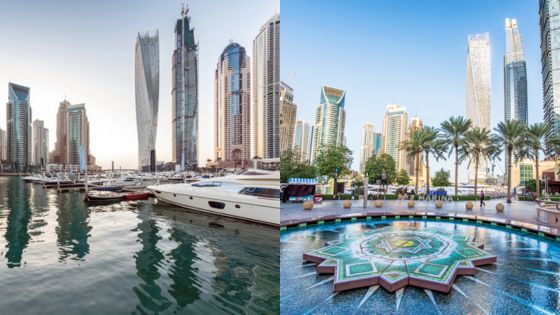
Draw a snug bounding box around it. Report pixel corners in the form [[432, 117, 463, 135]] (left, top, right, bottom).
[[462, 127, 493, 196]]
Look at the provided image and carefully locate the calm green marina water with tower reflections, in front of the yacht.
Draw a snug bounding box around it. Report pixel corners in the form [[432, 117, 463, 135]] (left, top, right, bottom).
[[0, 177, 280, 314]]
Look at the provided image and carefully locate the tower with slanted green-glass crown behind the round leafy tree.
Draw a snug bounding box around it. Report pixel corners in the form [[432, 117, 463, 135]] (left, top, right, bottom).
[[312, 85, 346, 159]]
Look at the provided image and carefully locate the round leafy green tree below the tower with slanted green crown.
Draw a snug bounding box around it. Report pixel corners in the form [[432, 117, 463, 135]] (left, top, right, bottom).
[[315, 145, 352, 194]]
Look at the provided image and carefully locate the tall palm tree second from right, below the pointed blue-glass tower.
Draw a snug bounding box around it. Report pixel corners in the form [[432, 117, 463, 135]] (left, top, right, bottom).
[[494, 120, 527, 203]]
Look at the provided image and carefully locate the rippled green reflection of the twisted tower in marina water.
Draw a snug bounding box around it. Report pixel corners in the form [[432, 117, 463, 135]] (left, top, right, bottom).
[[133, 207, 171, 314]]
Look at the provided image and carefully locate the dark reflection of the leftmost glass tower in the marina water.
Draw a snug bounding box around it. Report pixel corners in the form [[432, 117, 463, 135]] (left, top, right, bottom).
[[4, 177, 31, 268]]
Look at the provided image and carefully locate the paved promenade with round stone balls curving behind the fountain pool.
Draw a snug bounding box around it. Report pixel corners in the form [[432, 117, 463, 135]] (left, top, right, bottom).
[[280, 198, 539, 226]]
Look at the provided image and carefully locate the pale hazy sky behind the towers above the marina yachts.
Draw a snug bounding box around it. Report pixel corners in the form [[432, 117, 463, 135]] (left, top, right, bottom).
[[0, 0, 280, 168]]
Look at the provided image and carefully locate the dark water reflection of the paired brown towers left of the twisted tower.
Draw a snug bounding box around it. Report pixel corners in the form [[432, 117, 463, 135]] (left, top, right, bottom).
[[56, 193, 91, 262]]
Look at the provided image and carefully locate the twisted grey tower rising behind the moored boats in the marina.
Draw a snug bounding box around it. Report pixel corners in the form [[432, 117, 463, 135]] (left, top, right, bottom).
[[134, 31, 159, 172]]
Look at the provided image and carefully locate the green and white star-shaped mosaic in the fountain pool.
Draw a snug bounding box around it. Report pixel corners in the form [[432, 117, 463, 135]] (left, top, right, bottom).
[[303, 227, 496, 292]]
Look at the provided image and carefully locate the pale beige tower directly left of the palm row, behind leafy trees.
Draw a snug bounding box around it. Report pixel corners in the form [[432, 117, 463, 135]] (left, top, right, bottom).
[[382, 104, 408, 171]]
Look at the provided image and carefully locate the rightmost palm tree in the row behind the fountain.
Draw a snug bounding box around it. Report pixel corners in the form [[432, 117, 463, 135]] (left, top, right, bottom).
[[521, 122, 551, 198]]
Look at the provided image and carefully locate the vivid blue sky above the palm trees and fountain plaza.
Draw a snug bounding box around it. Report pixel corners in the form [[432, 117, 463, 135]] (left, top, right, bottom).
[[281, 0, 543, 180]]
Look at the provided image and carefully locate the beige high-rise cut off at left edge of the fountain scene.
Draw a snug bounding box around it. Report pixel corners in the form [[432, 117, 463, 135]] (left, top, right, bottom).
[[280, 82, 297, 152]]
